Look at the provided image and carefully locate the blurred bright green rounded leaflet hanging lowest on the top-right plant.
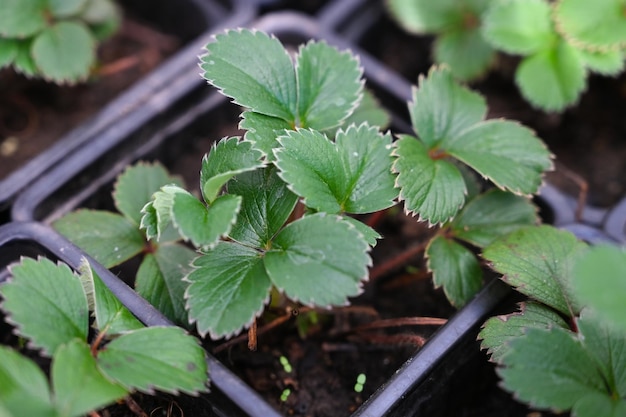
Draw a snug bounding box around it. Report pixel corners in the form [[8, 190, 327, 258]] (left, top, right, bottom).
[[515, 40, 586, 111]]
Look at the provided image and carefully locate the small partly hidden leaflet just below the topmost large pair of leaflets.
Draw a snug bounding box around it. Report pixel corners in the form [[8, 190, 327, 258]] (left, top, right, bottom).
[[239, 111, 292, 161]]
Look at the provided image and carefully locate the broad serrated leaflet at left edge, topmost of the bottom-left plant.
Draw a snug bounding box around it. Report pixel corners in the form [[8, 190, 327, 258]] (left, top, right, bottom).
[[0, 258, 89, 356]]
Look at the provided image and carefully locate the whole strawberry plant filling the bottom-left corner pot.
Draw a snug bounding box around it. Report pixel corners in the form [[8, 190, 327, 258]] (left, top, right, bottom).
[[0, 258, 207, 417]]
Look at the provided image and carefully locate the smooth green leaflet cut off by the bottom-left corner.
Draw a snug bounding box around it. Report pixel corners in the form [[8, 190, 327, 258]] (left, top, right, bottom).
[[0, 346, 57, 417]]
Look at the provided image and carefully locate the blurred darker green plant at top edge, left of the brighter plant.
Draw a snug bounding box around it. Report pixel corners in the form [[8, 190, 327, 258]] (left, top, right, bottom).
[[387, 0, 496, 80]]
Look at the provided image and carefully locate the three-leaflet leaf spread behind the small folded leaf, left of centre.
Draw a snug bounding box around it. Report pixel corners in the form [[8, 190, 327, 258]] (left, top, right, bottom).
[[52, 163, 196, 326]]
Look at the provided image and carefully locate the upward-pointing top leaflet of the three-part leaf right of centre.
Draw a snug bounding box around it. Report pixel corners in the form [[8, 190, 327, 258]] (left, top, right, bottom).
[[409, 67, 487, 150]]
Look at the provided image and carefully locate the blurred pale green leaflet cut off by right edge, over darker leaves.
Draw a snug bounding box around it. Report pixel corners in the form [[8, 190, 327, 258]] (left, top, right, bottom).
[[572, 246, 626, 329]]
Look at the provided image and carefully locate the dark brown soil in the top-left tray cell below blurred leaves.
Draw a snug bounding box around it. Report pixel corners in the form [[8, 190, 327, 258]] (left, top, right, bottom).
[[0, 15, 180, 180]]
